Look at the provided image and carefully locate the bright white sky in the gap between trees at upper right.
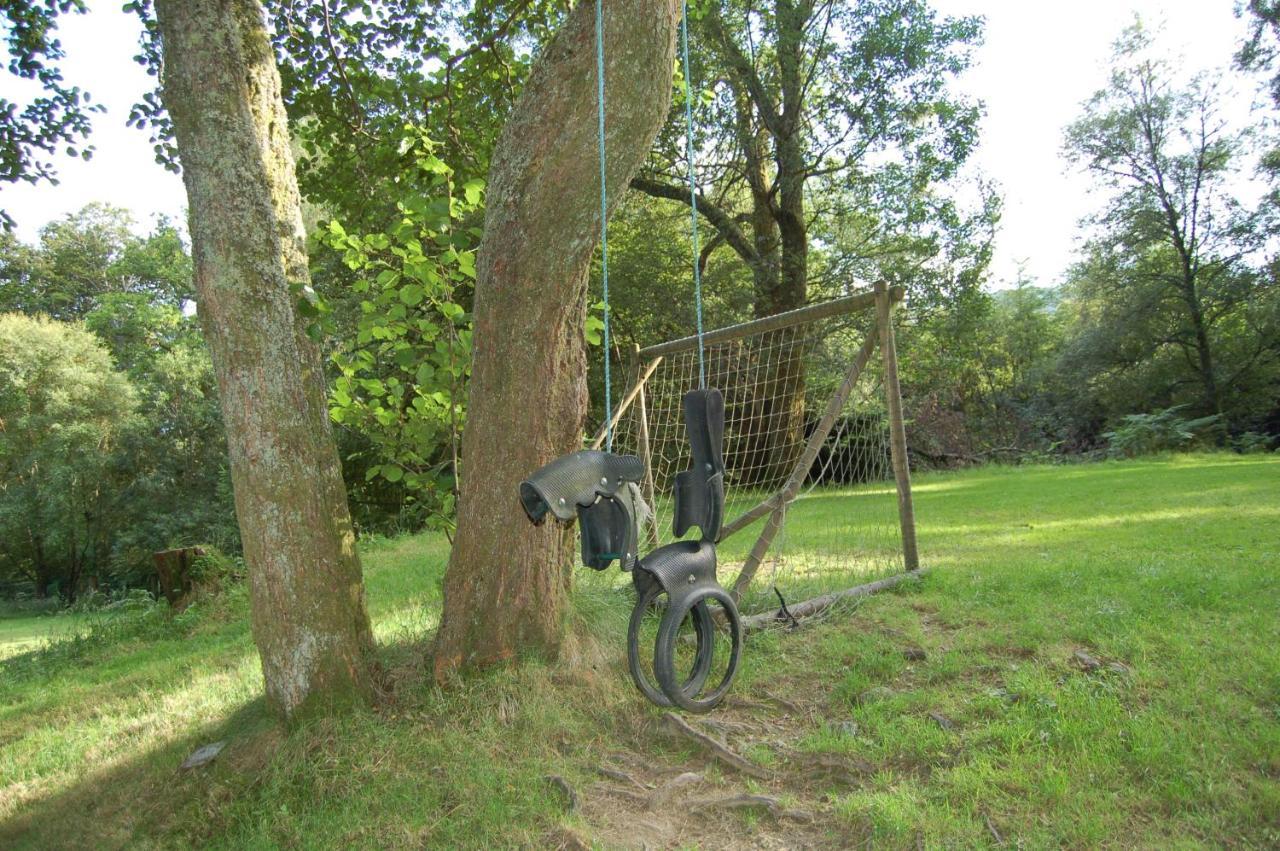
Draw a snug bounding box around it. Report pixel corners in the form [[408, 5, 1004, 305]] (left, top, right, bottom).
[[931, 0, 1253, 287]]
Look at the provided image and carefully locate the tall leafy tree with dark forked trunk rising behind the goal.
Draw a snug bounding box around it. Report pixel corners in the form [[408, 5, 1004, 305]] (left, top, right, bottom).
[[632, 0, 980, 316]]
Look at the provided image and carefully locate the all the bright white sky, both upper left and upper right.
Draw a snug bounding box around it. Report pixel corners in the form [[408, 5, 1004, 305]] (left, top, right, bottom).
[[0, 0, 1252, 287]]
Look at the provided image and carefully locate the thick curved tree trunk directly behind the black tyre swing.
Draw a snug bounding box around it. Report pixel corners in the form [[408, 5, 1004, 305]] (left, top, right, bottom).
[[435, 0, 680, 678]]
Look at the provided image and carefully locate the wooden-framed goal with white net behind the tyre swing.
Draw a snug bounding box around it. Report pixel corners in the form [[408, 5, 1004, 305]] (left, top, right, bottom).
[[593, 290, 914, 612]]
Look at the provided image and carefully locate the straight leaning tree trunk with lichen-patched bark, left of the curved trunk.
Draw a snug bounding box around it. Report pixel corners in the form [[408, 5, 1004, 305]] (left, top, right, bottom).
[[156, 0, 372, 719]]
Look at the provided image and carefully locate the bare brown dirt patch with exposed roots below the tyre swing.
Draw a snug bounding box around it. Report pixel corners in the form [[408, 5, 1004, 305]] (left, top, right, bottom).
[[568, 683, 874, 848]]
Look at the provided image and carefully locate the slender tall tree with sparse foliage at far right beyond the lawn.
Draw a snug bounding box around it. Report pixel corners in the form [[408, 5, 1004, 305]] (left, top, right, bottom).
[[1065, 22, 1270, 427]]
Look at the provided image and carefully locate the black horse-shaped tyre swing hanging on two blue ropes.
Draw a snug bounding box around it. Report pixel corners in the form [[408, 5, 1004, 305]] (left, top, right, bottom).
[[520, 0, 742, 712]]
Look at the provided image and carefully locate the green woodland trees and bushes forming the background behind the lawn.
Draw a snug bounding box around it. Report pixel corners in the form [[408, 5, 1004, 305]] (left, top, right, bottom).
[[0, 0, 1280, 604]]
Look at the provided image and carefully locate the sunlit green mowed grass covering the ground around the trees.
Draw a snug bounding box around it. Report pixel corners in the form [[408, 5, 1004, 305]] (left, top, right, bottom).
[[0, 454, 1280, 848]]
